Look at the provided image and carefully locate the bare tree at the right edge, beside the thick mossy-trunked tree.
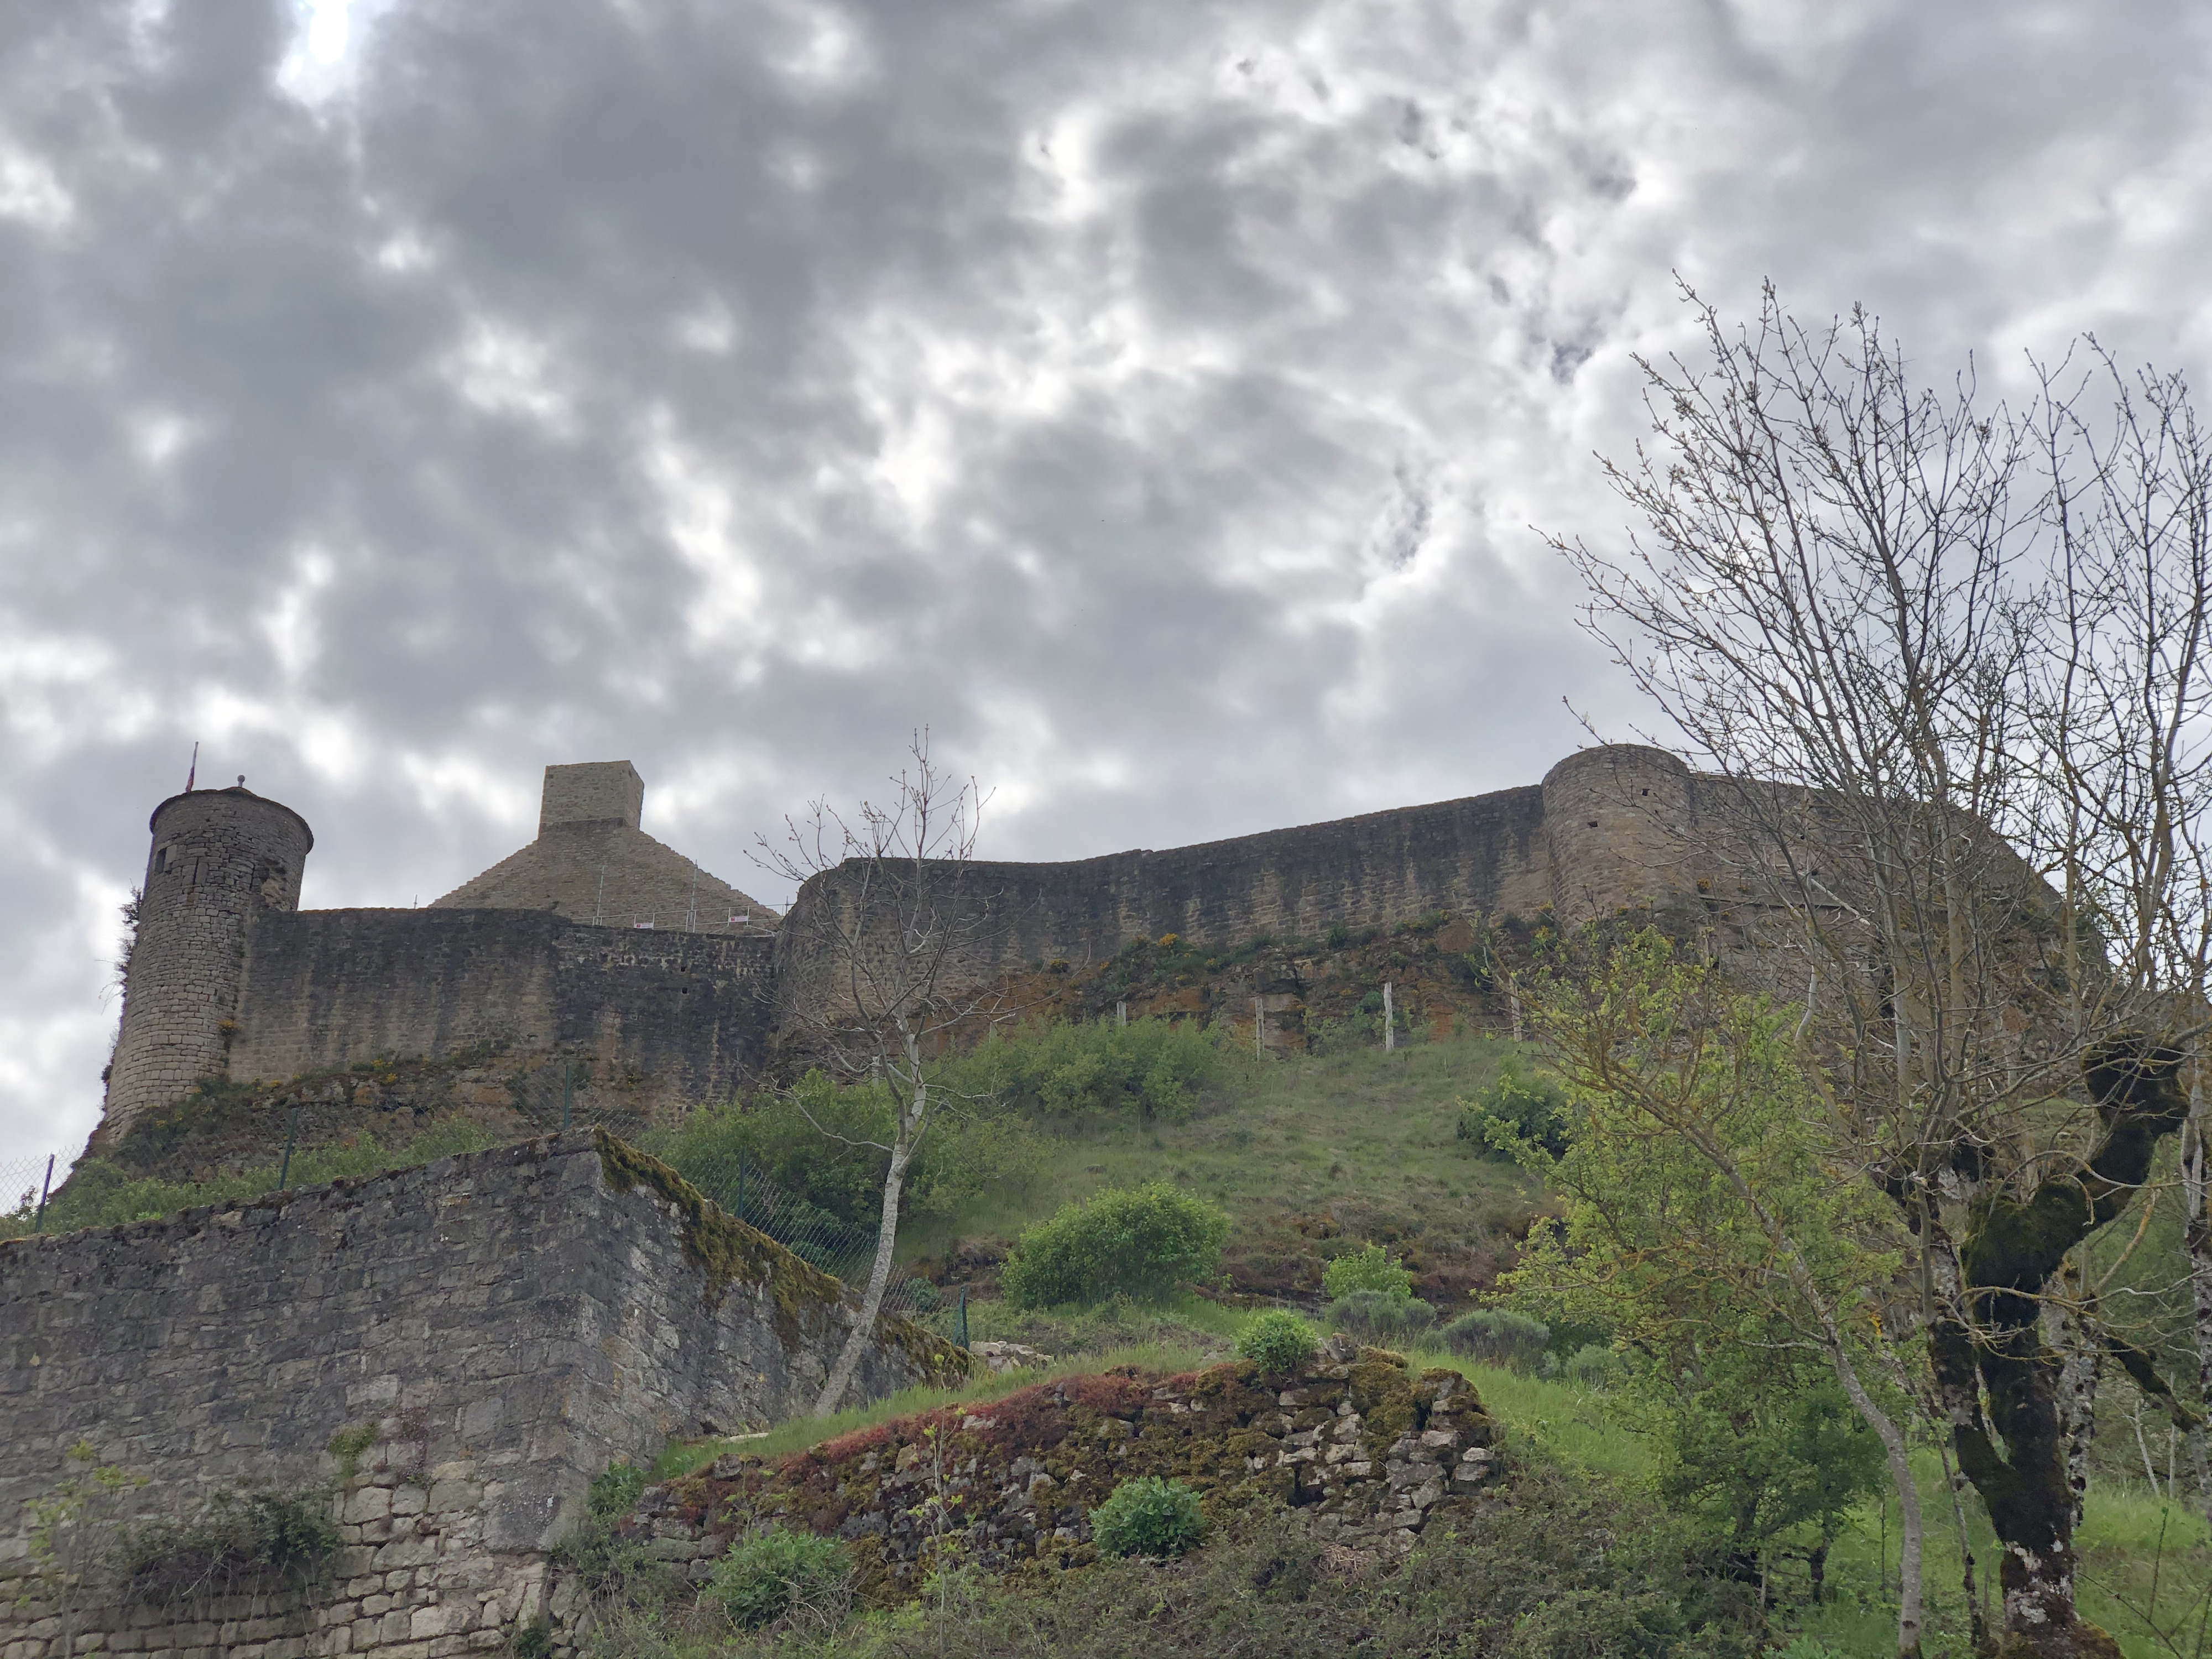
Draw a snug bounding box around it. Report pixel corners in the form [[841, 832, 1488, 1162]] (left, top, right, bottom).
[[2017, 352, 2212, 1515]]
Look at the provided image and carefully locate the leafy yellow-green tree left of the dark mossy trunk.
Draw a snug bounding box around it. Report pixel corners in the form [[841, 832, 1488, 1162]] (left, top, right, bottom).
[[1504, 929, 1918, 1639]]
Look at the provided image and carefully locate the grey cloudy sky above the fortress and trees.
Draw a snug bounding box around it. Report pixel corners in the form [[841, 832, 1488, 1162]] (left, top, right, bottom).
[[0, 0, 2212, 1164]]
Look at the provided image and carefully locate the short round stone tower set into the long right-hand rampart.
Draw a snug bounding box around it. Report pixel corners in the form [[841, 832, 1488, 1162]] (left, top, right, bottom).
[[1544, 743, 1694, 927]]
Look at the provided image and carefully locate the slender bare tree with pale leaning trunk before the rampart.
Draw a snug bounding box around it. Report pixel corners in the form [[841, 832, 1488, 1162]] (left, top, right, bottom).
[[757, 730, 993, 1416]]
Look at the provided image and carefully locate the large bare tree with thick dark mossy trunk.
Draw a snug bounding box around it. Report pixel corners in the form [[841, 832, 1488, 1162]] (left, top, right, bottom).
[[1553, 290, 2183, 1655]]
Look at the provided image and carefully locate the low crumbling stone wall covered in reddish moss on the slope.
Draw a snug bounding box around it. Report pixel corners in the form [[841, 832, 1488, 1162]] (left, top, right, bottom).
[[562, 1338, 1502, 1639]]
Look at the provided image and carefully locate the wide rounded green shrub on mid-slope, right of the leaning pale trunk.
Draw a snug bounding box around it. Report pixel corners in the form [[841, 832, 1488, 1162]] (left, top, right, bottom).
[[1000, 1181, 1230, 1307]]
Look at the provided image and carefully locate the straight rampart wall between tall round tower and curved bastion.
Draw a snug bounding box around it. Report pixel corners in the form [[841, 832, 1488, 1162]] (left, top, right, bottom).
[[228, 909, 772, 1099]]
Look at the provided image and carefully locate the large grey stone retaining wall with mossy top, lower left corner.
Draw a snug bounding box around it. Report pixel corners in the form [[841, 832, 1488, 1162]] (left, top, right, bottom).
[[0, 1133, 964, 1659]]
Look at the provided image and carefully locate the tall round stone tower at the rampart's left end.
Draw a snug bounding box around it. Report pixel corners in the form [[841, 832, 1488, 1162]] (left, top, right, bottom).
[[100, 783, 314, 1137]]
